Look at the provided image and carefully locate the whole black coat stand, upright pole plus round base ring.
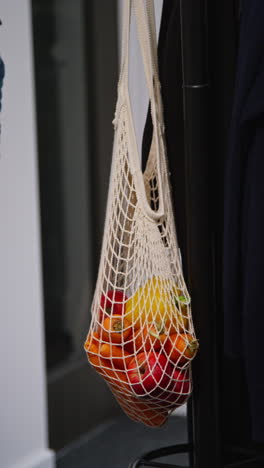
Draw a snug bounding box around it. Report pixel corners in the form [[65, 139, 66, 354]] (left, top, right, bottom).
[[130, 0, 264, 468]]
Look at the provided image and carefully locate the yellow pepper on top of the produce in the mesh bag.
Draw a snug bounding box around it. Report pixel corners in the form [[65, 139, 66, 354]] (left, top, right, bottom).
[[126, 277, 190, 334]]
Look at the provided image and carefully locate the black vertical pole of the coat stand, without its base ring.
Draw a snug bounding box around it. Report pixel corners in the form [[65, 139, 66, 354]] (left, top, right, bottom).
[[181, 0, 221, 468]]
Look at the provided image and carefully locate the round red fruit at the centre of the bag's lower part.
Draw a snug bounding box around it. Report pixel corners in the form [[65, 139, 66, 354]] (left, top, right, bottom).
[[127, 352, 173, 395]]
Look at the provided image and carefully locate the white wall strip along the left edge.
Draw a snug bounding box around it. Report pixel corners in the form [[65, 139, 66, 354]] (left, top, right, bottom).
[[0, 0, 54, 468]]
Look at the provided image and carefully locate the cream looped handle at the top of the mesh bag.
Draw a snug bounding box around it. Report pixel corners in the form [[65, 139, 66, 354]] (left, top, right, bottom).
[[118, 0, 165, 220]]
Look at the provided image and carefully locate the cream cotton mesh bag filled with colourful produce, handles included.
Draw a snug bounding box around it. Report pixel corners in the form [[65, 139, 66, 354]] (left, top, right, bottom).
[[84, 0, 198, 427]]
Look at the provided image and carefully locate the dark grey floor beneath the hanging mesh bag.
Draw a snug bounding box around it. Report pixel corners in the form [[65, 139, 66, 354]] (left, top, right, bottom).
[[57, 416, 188, 468]]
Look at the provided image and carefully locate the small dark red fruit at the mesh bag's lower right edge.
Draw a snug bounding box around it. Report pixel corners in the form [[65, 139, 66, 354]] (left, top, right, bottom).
[[156, 368, 192, 407]]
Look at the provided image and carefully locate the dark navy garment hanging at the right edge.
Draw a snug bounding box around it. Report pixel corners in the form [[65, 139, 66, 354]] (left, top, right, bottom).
[[223, 0, 264, 442]]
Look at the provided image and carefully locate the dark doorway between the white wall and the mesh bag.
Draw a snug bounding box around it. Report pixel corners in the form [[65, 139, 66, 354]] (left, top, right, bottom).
[[32, 0, 119, 450]]
